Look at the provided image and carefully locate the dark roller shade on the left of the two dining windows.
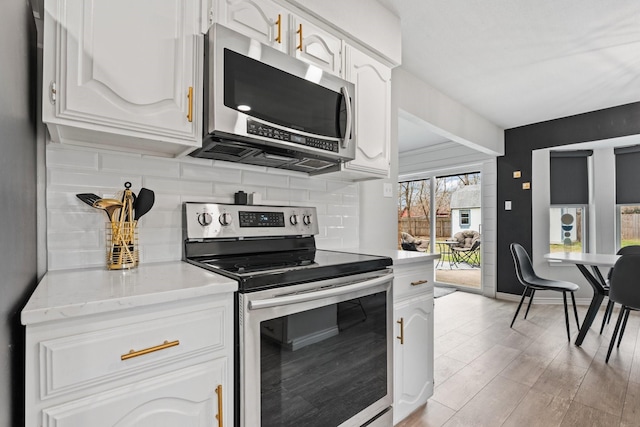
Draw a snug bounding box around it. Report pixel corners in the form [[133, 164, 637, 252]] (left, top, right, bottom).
[[549, 150, 593, 205]]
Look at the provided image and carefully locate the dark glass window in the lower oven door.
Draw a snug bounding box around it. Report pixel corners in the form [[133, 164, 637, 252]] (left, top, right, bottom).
[[260, 292, 387, 427]]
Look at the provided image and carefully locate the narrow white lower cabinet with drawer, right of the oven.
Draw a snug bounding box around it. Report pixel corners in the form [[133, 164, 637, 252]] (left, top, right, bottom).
[[393, 261, 433, 424]]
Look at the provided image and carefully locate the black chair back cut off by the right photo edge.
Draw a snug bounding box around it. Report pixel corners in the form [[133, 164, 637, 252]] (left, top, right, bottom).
[[609, 253, 640, 310]]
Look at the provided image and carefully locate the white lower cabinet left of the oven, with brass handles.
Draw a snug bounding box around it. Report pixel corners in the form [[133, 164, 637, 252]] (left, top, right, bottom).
[[26, 292, 233, 427]]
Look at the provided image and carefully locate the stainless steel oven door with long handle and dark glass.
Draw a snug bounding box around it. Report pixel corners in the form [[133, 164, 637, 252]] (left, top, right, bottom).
[[239, 270, 393, 427]]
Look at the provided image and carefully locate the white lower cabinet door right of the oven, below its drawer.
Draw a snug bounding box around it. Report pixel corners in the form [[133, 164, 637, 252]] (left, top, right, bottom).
[[393, 293, 433, 424]]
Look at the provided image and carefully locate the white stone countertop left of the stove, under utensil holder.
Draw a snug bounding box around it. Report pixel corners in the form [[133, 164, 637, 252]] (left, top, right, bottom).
[[21, 261, 238, 325]]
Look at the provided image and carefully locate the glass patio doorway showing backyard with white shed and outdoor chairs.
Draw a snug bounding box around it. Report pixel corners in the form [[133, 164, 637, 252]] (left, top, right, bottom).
[[398, 172, 482, 291]]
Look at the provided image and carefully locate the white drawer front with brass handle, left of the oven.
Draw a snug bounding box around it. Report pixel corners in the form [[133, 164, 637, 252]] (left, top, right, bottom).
[[39, 307, 225, 399]]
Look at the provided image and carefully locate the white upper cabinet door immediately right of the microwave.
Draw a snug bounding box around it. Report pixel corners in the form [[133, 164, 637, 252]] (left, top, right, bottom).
[[345, 46, 391, 177]]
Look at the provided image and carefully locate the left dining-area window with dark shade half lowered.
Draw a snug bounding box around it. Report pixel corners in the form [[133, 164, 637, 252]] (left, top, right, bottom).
[[549, 150, 593, 252]]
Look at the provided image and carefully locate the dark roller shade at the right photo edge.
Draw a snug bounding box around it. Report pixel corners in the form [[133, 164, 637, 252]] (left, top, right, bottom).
[[614, 145, 640, 205]]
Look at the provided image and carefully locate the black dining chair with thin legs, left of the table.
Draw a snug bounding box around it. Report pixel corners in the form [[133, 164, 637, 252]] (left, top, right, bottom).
[[509, 243, 580, 341]]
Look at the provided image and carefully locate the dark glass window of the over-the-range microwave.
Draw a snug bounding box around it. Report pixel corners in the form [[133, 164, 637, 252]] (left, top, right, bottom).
[[224, 49, 346, 138]]
